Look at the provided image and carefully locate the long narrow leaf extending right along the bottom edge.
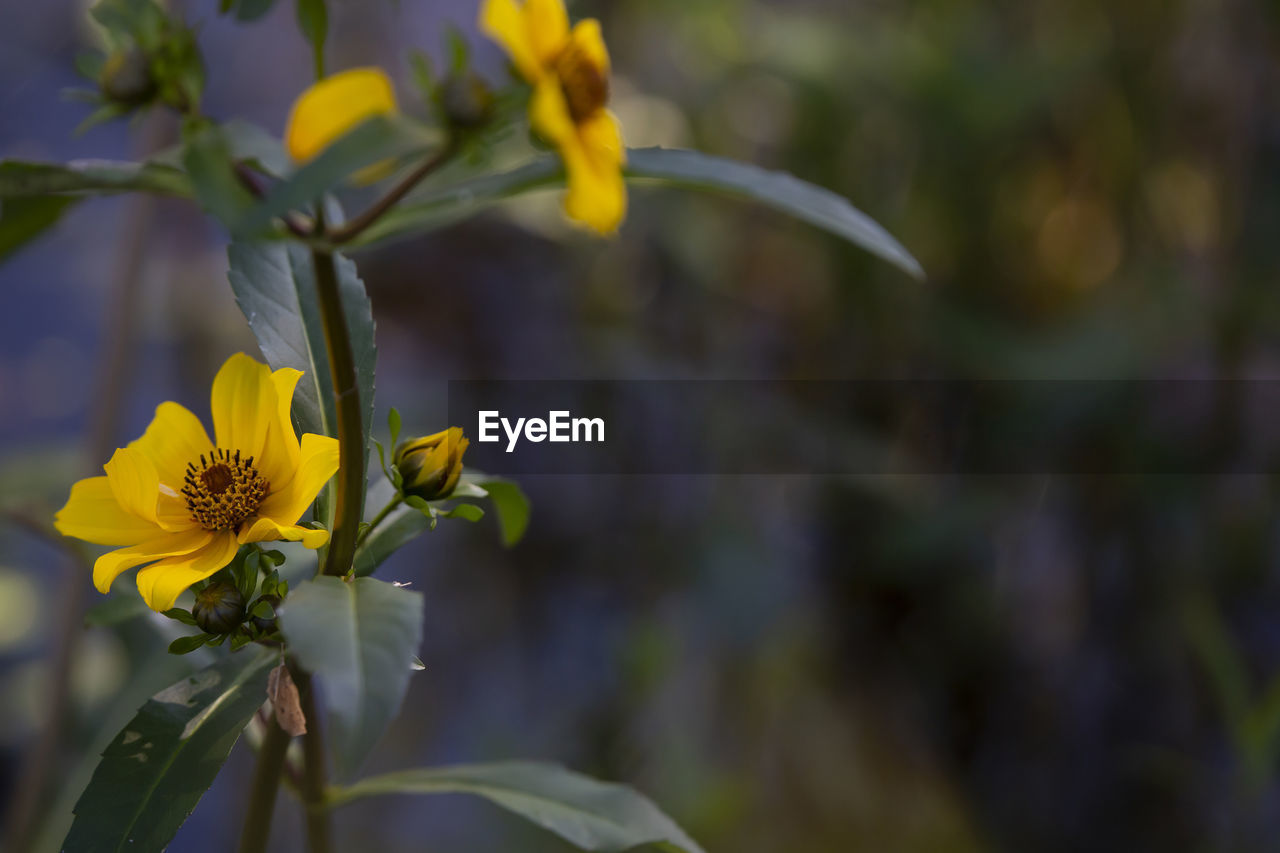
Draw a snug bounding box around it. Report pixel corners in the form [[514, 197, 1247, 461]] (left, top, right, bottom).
[[320, 761, 701, 853]]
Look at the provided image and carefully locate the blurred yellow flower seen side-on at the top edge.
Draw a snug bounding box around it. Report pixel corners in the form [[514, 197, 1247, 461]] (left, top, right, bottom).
[[480, 0, 627, 234]]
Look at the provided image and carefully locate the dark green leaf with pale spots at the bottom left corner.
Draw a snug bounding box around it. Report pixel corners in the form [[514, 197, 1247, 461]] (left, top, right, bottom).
[[61, 649, 279, 853]]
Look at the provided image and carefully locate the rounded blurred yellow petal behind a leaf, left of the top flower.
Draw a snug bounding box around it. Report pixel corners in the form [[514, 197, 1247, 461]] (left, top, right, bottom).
[[284, 68, 397, 163]]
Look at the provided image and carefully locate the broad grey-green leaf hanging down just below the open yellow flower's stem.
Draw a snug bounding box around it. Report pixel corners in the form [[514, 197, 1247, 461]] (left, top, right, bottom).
[[279, 576, 422, 779]]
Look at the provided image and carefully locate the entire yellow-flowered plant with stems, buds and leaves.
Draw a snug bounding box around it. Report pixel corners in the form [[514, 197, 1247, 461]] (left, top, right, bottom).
[[0, 0, 919, 853]]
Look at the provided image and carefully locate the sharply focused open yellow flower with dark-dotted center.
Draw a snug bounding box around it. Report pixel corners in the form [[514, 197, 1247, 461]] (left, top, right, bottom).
[[55, 353, 338, 611]]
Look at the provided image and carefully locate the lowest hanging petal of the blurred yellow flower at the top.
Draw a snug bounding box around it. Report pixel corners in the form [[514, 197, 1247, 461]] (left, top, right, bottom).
[[561, 111, 627, 234]]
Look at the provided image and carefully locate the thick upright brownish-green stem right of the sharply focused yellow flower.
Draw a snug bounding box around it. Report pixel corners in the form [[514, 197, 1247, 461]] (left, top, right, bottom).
[[311, 233, 365, 576]]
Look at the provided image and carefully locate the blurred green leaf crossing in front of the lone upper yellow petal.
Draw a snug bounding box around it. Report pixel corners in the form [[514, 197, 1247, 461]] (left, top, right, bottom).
[[232, 115, 439, 234]]
